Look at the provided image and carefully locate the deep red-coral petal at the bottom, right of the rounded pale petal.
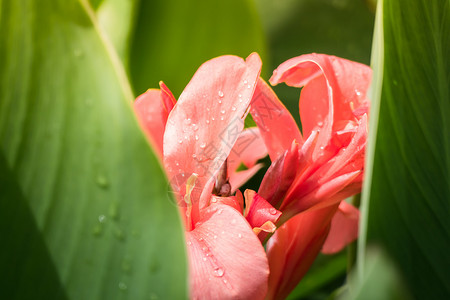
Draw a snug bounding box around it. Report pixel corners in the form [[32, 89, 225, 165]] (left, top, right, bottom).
[[266, 205, 337, 299]]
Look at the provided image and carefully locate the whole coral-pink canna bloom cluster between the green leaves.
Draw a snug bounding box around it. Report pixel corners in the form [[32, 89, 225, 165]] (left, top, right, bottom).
[[135, 54, 370, 299]]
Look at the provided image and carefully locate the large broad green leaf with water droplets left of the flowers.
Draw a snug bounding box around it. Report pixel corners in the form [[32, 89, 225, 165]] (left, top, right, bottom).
[[0, 0, 187, 299]]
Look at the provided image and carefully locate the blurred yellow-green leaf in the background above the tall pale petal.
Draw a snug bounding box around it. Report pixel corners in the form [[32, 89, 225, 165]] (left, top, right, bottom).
[[130, 0, 266, 96]]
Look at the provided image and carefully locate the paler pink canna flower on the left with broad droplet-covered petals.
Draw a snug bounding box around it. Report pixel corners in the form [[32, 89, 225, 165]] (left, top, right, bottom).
[[135, 53, 280, 299]]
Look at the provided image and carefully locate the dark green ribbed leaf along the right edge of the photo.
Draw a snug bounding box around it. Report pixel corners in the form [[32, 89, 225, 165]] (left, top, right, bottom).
[[360, 0, 450, 299]]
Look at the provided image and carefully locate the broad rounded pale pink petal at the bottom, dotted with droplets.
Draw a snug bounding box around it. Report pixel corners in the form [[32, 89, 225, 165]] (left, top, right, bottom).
[[186, 204, 269, 299]]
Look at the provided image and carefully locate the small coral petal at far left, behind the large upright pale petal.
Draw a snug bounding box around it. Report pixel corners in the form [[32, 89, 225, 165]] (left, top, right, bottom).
[[134, 87, 170, 159]]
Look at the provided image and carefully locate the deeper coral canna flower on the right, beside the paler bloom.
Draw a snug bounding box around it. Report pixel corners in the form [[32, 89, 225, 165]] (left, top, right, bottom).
[[251, 54, 371, 299]]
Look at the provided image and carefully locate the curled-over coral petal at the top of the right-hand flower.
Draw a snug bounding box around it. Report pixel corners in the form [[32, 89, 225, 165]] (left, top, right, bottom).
[[270, 54, 371, 160]]
